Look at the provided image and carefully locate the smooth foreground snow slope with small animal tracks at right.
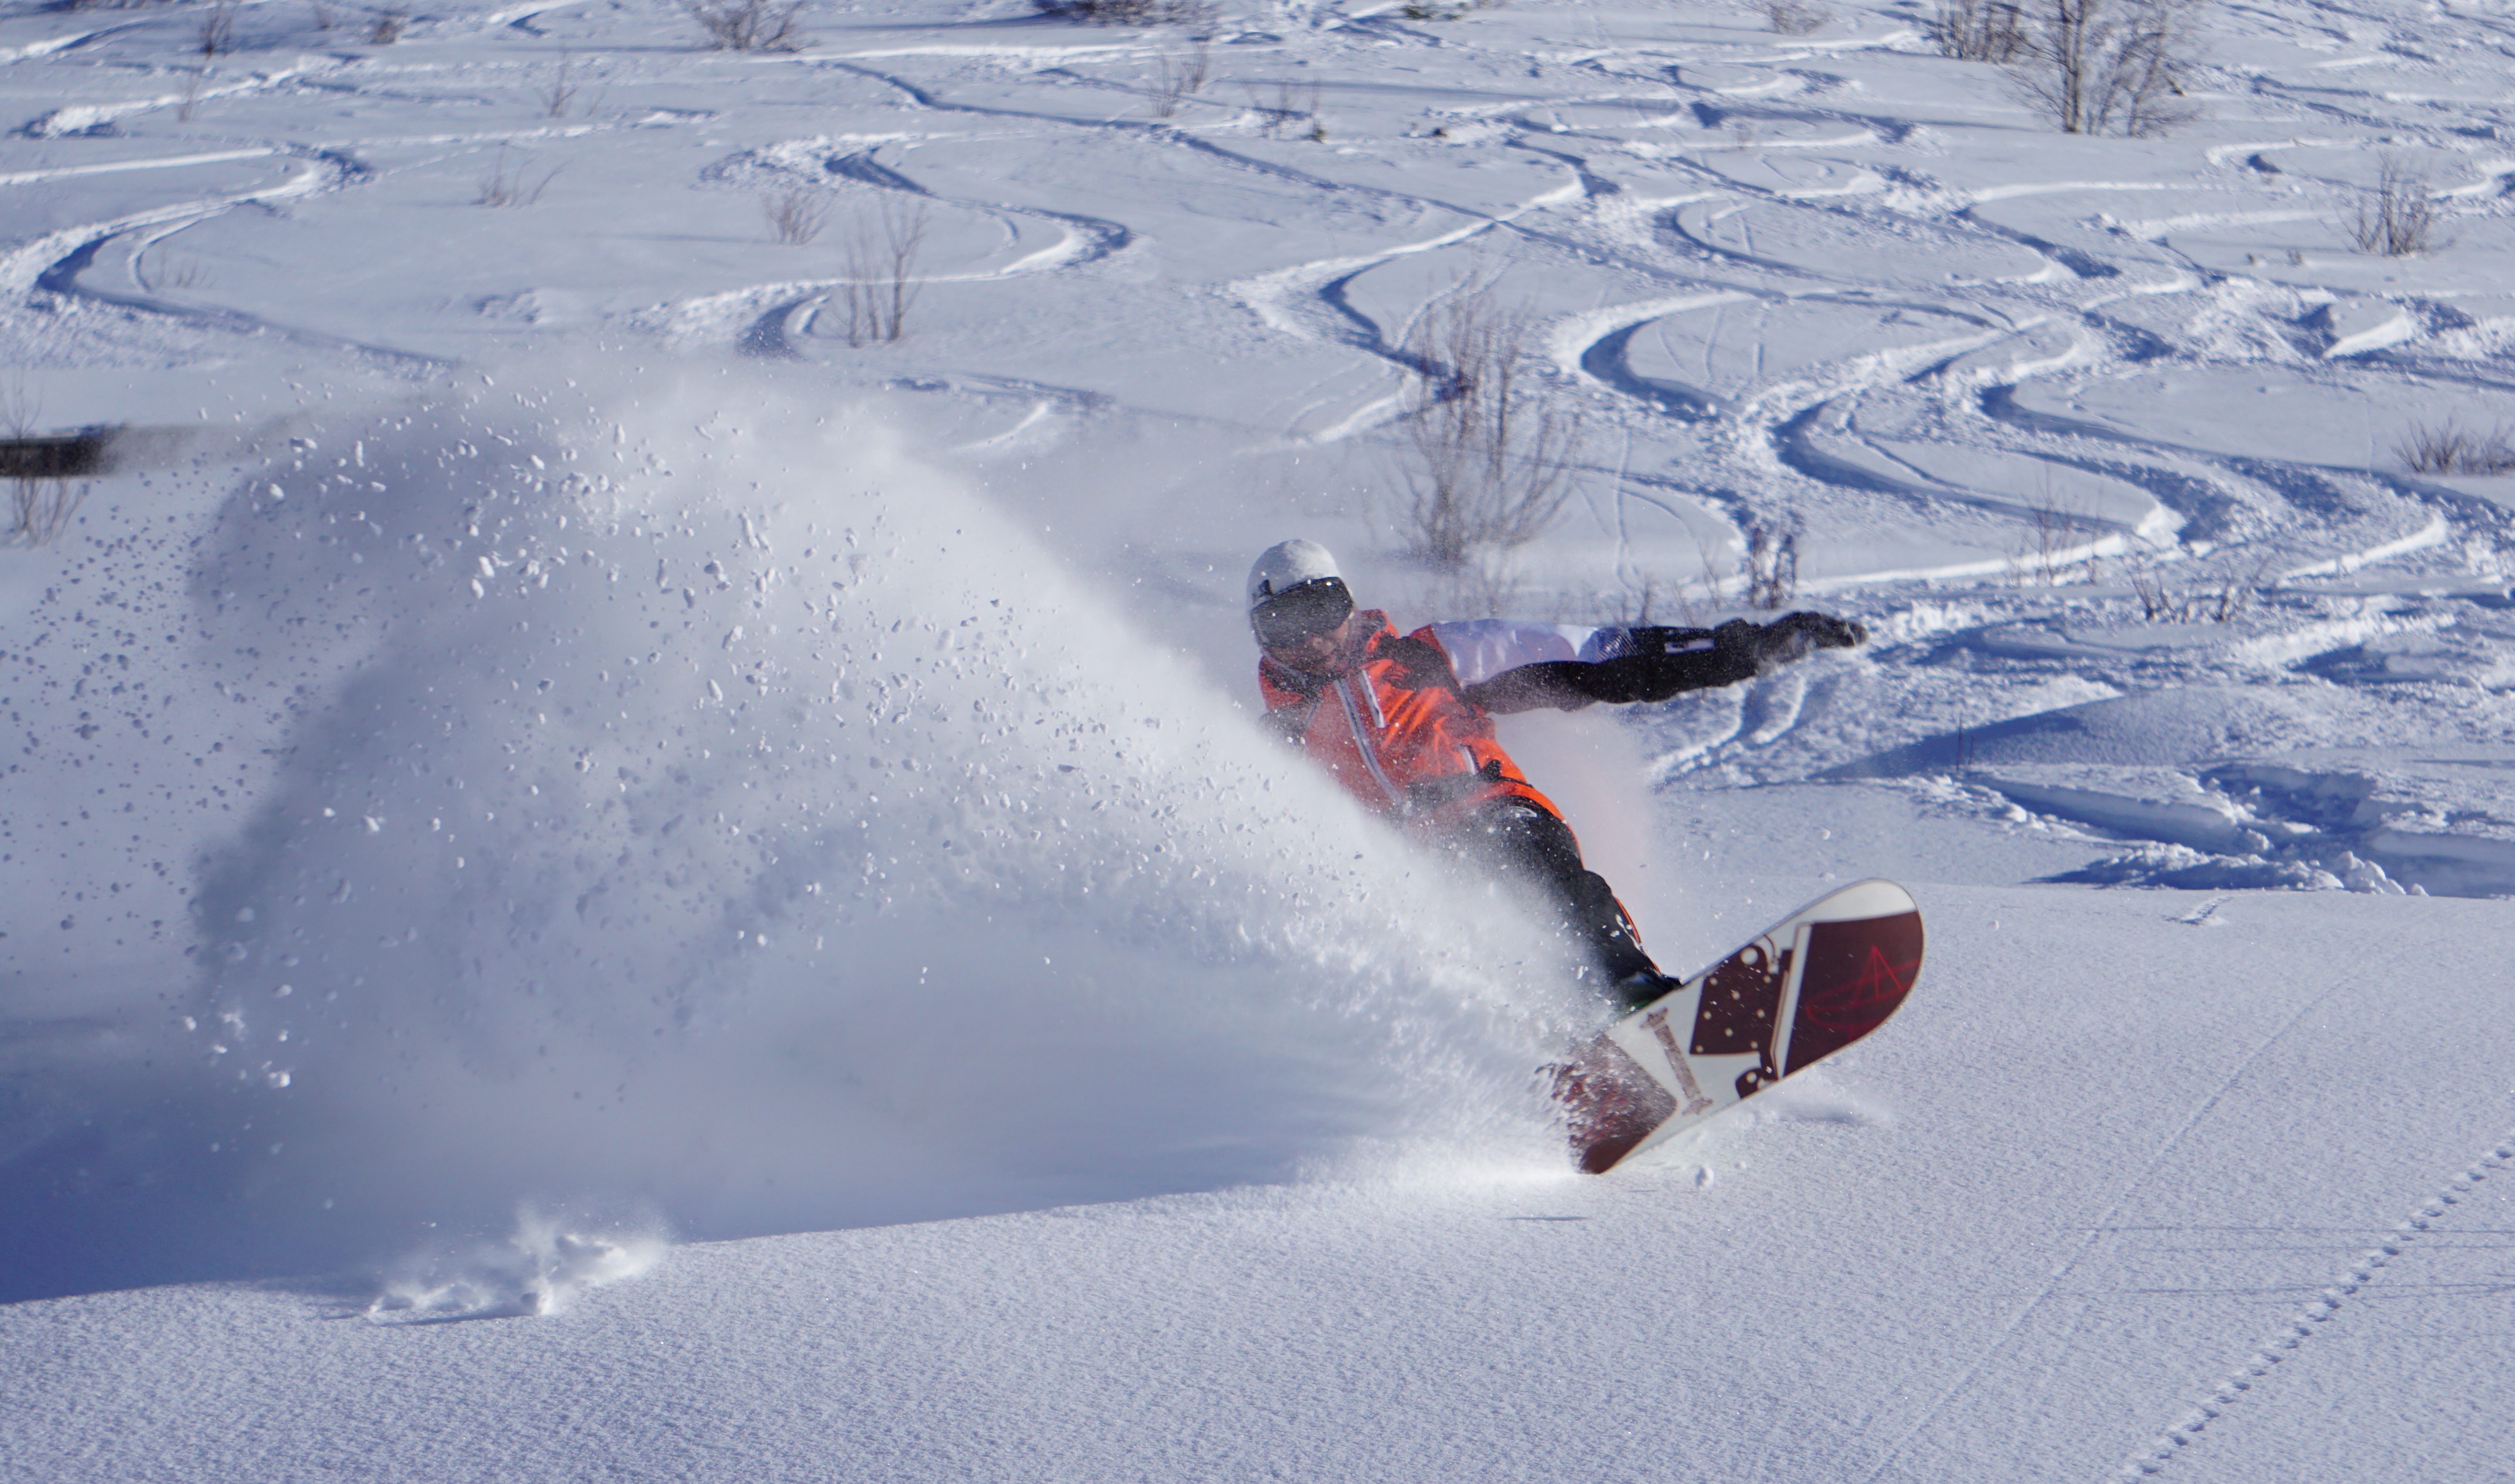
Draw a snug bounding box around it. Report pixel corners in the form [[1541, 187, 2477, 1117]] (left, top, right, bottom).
[[0, 888, 2515, 1481]]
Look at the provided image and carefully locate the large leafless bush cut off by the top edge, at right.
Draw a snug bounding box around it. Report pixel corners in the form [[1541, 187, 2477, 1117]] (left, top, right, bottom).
[[2015, 0, 2198, 138]]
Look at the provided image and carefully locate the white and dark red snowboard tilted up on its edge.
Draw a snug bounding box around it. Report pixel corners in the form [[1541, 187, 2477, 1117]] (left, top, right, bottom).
[[1544, 880, 1922, 1175]]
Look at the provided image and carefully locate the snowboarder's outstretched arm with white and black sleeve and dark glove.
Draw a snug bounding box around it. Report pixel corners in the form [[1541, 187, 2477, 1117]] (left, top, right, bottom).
[[1431, 614, 1868, 714]]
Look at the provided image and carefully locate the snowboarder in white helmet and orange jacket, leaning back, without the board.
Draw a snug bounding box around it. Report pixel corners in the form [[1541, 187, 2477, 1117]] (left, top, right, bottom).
[[1247, 541, 1866, 1011]]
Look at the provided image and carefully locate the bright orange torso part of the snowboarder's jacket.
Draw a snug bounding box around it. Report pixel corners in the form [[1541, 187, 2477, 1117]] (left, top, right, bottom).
[[1258, 608, 1562, 832]]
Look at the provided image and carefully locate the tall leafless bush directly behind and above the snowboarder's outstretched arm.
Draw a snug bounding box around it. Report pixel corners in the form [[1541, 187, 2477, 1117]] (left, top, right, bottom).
[[1393, 284, 1579, 574]]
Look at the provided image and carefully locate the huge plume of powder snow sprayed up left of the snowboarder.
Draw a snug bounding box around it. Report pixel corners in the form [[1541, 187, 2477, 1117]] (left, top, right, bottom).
[[0, 367, 1567, 1308]]
